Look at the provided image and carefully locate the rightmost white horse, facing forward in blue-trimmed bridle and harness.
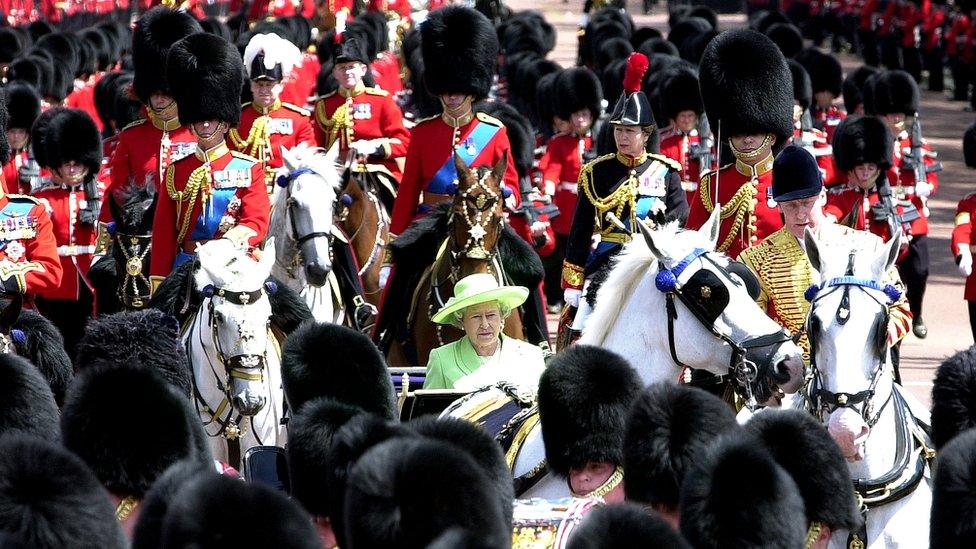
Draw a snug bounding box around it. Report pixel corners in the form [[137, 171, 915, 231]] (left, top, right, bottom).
[[804, 231, 932, 548]]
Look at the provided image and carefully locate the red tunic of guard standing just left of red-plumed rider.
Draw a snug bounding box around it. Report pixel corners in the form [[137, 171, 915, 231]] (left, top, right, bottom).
[[539, 134, 593, 236]]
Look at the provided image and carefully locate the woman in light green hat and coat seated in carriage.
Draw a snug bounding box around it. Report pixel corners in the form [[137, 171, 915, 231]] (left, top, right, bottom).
[[424, 274, 545, 391]]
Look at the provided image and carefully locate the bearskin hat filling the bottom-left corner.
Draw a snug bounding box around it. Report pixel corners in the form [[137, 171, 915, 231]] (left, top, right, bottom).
[[0, 433, 128, 549]]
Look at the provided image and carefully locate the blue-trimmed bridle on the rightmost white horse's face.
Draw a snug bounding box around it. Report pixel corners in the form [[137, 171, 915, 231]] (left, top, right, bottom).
[[805, 251, 901, 428]]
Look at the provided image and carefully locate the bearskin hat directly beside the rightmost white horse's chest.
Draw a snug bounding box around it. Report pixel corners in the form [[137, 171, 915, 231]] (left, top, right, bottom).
[[746, 410, 860, 531]]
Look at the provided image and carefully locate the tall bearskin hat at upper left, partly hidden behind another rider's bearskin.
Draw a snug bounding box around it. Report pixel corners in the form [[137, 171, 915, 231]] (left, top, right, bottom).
[[132, 6, 203, 103]]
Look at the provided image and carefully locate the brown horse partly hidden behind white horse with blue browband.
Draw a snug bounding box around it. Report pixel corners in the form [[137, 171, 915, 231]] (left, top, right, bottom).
[[336, 163, 395, 307]]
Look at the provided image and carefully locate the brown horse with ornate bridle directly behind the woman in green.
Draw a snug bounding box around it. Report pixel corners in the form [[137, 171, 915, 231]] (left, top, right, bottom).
[[388, 155, 524, 366]]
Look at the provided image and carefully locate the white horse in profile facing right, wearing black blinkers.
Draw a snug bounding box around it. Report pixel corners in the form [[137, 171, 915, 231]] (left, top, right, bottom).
[[450, 209, 803, 499]]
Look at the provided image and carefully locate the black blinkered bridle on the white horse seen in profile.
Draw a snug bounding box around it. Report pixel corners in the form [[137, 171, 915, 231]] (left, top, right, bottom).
[[654, 248, 791, 410]]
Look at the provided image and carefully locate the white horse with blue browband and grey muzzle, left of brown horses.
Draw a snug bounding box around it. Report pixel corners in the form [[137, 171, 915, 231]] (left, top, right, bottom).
[[268, 145, 345, 323]]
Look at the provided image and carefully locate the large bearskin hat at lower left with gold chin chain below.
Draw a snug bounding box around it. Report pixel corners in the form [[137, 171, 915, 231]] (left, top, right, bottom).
[[61, 364, 210, 498]]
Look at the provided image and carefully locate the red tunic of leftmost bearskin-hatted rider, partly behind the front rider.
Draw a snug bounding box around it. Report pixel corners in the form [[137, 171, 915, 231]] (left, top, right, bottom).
[[99, 119, 197, 222]]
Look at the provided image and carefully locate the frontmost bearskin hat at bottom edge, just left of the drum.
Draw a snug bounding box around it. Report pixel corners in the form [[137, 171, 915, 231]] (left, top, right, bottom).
[[343, 438, 512, 547]]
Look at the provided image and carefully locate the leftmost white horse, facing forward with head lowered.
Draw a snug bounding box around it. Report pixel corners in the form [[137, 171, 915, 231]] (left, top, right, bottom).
[[183, 239, 285, 466]]
